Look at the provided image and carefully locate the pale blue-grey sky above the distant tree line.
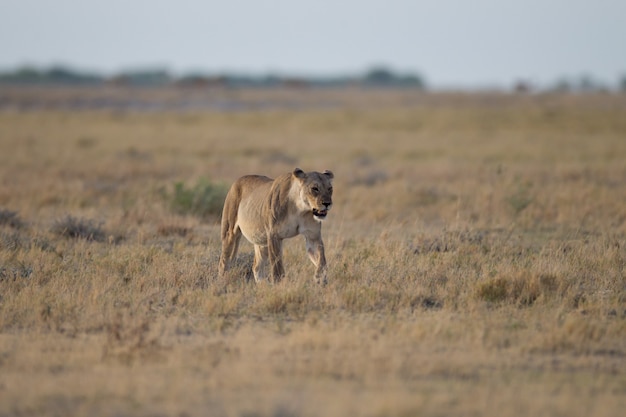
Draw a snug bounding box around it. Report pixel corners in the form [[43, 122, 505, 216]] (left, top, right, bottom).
[[0, 0, 626, 87]]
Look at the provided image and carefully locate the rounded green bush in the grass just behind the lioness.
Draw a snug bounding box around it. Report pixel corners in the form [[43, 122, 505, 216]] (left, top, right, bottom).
[[168, 178, 228, 219]]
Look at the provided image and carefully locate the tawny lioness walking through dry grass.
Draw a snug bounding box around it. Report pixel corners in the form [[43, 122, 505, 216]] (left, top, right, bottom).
[[219, 168, 334, 284]]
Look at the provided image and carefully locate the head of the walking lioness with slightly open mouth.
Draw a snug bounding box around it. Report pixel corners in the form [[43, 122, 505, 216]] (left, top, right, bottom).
[[292, 168, 334, 221]]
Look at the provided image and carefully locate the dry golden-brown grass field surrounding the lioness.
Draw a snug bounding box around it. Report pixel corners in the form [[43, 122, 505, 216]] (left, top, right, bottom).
[[0, 86, 626, 417]]
